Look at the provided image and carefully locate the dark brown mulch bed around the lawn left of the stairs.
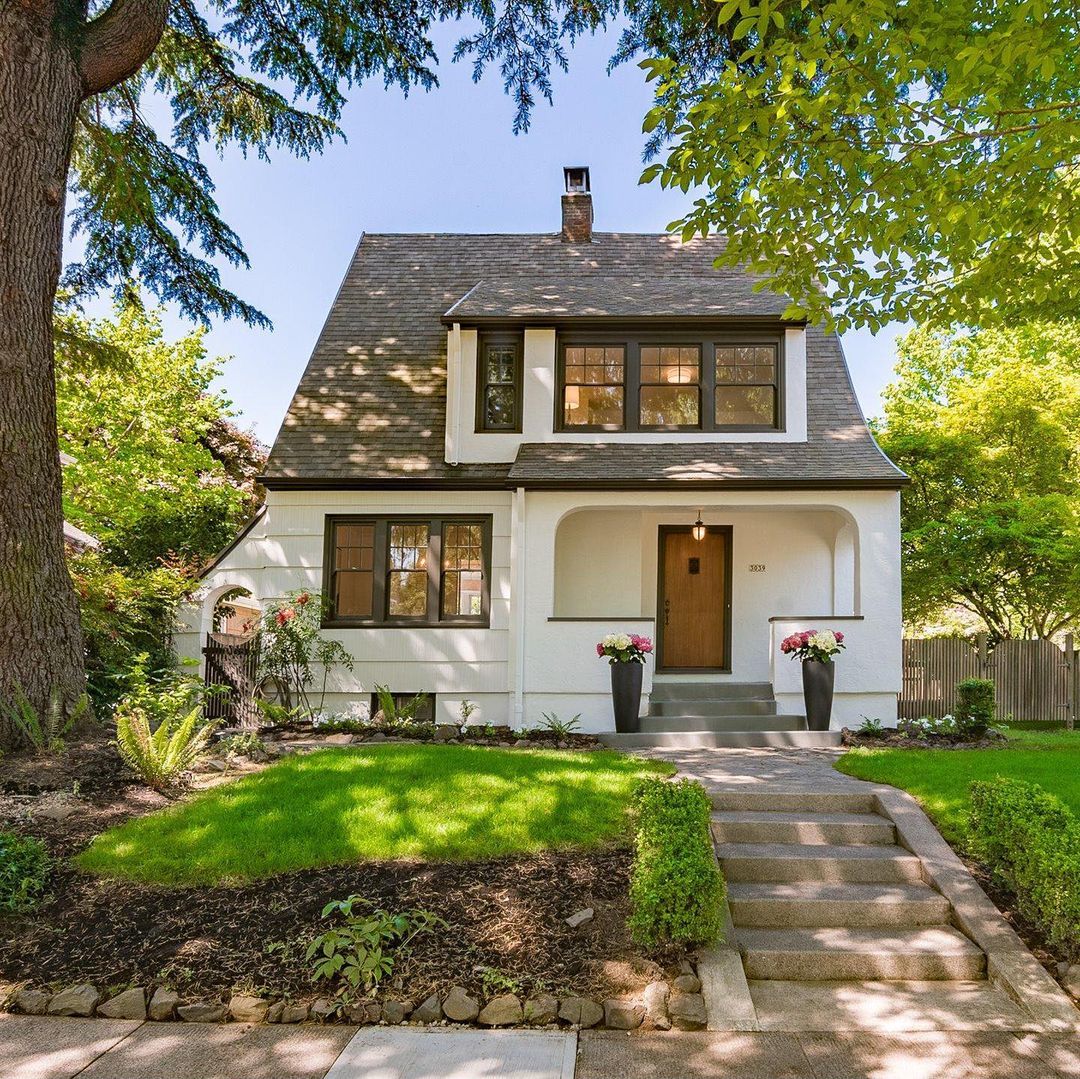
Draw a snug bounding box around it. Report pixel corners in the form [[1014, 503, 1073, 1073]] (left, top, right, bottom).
[[0, 737, 679, 1000]]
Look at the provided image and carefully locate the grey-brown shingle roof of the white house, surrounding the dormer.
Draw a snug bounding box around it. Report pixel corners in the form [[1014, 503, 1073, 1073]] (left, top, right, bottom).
[[265, 233, 903, 487]]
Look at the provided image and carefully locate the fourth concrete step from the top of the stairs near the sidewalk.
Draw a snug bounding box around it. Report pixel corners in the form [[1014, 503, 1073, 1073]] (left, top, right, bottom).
[[728, 882, 949, 929]]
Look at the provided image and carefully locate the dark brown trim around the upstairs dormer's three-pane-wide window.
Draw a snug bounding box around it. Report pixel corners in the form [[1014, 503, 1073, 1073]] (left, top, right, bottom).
[[554, 326, 787, 434]]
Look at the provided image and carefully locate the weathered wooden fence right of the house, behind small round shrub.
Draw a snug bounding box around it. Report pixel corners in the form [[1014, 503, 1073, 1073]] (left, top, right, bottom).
[[899, 634, 1080, 728]]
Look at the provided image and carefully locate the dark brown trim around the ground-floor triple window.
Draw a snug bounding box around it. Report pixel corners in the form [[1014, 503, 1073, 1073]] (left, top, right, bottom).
[[322, 513, 491, 630]]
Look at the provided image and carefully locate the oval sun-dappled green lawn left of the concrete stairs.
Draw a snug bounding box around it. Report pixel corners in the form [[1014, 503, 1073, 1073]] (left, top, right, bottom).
[[77, 744, 674, 886]]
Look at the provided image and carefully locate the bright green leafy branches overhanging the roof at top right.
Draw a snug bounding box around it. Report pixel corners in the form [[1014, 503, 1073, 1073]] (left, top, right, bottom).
[[644, 0, 1080, 329]]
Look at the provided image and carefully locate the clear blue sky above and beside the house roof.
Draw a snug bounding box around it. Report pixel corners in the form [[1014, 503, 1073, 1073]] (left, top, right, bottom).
[[113, 26, 903, 443]]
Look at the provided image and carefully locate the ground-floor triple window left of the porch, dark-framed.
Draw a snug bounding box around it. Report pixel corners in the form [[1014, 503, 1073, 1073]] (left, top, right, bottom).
[[324, 515, 491, 625]]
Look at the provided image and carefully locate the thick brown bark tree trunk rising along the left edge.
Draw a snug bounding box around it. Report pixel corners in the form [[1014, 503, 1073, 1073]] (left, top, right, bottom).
[[0, 0, 84, 738]]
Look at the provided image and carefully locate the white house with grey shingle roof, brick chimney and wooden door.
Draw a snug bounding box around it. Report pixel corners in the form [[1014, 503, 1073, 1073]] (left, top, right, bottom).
[[179, 170, 905, 744]]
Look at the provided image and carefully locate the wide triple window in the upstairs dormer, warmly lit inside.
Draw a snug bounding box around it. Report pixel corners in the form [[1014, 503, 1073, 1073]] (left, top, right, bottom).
[[555, 329, 783, 432]]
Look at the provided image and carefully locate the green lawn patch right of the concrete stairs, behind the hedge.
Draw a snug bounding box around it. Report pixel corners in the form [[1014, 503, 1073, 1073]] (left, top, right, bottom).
[[836, 729, 1080, 846]]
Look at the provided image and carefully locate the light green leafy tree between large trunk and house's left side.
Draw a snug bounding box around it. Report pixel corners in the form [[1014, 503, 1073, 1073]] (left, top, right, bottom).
[[56, 304, 265, 568]]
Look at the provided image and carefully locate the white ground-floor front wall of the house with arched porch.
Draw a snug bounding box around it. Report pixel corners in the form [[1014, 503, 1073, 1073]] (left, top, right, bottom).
[[177, 490, 902, 731]]
